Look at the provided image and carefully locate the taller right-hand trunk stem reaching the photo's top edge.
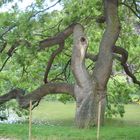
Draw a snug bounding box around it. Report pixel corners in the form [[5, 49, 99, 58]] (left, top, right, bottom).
[[93, 0, 120, 124]]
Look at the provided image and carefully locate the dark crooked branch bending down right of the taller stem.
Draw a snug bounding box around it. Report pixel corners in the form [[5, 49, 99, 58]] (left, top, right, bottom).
[[113, 46, 140, 86]]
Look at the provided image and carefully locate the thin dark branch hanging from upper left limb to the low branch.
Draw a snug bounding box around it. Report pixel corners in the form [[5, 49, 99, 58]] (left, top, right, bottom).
[[44, 42, 64, 83]]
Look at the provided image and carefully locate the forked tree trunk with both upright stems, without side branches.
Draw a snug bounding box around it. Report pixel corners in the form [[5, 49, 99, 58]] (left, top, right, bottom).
[[72, 0, 120, 128]]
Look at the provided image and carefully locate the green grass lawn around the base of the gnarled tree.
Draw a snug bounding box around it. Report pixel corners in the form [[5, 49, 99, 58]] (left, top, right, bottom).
[[0, 101, 140, 140]]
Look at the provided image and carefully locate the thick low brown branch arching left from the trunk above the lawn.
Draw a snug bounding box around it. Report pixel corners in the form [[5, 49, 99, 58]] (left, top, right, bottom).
[[0, 83, 75, 108]]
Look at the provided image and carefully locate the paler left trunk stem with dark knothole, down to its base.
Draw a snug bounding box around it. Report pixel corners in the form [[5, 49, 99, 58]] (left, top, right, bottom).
[[71, 24, 94, 128]]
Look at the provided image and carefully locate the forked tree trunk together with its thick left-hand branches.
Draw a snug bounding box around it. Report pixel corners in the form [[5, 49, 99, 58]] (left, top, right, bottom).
[[0, 0, 120, 128]]
